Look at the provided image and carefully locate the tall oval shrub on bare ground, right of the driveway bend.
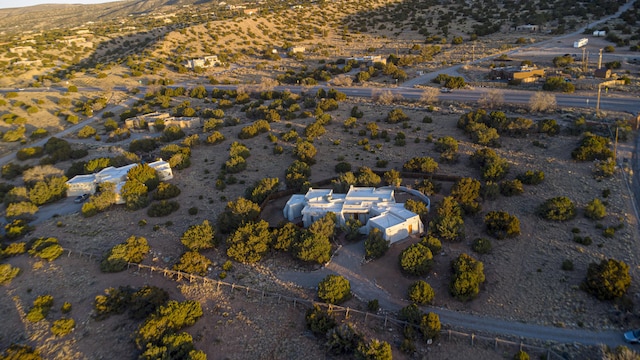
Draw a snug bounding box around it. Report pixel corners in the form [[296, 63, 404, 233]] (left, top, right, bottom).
[[449, 254, 485, 301]]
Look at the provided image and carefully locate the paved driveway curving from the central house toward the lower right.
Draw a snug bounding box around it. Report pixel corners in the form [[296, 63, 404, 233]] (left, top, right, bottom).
[[276, 242, 625, 347]]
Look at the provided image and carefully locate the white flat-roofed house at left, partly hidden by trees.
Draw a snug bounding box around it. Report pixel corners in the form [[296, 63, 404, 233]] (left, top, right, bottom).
[[67, 159, 173, 200]]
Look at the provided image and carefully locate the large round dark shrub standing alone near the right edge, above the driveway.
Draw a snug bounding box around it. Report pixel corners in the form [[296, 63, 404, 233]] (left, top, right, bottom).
[[583, 259, 631, 300]]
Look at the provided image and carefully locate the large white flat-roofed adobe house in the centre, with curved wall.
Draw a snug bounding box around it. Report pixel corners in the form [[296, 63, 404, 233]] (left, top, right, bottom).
[[283, 186, 424, 243]]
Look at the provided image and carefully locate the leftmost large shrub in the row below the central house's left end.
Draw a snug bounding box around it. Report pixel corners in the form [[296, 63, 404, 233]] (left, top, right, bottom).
[[227, 220, 273, 264]]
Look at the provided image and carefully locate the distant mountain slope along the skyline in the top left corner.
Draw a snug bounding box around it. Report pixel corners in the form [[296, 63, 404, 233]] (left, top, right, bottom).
[[0, 0, 217, 34]]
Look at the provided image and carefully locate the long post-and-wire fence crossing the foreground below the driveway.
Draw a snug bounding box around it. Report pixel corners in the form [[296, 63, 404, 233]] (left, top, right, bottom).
[[65, 249, 565, 360]]
